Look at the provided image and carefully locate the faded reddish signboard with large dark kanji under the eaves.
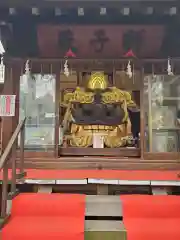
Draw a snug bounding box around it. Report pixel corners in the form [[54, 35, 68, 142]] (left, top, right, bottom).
[[38, 25, 165, 58]]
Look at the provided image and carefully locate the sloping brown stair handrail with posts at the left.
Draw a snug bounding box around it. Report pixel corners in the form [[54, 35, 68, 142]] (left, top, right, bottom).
[[0, 118, 26, 219]]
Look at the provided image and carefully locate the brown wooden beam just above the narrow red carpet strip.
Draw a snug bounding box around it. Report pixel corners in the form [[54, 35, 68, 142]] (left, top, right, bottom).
[[14, 156, 180, 170]]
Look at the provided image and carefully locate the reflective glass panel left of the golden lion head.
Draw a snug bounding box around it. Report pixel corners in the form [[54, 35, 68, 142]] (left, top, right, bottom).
[[19, 74, 56, 149]]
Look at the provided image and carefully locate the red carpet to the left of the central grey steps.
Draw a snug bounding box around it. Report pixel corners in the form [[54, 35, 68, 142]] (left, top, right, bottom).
[[2, 193, 85, 240]]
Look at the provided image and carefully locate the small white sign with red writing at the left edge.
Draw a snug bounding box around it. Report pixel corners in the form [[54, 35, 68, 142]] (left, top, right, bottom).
[[0, 95, 16, 117]]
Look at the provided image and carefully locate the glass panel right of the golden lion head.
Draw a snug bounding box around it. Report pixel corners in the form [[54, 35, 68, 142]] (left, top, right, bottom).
[[144, 75, 180, 152]]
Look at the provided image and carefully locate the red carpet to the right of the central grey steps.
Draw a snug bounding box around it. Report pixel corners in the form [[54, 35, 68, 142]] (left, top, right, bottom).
[[120, 195, 180, 240]]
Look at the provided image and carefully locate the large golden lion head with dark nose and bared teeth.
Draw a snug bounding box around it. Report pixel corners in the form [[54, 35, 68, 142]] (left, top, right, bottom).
[[59, 71, 140, 157]]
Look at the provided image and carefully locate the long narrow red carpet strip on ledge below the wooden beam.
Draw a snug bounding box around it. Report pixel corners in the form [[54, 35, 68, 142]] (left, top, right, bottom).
[[0, 169, 180, 181]]
